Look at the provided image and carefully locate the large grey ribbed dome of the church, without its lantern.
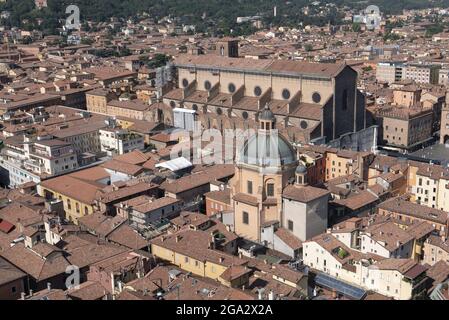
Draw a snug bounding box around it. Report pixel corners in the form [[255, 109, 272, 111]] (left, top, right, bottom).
[[238, 131, 296, 167]]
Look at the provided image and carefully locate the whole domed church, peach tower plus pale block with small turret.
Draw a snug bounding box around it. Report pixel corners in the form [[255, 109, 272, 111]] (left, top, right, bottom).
[[231, 106, 329, 242]]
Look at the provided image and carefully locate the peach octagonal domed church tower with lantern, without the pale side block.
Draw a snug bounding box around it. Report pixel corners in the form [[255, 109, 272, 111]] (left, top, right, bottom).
[[231, 108, 298, 242]]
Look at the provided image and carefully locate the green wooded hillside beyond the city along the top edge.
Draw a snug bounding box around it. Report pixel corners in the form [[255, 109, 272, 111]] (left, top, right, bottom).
[[0, 0, 449, 32]]
